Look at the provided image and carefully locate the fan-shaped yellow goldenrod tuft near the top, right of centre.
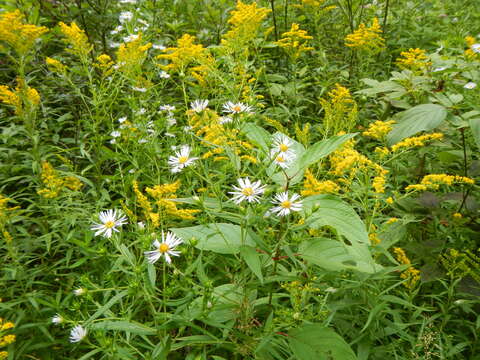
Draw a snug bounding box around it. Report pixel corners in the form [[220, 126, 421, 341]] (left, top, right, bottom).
[[345, 18, 385, 52]]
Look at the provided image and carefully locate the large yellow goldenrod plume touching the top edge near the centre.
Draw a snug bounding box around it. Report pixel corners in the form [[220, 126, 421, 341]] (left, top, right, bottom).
[[222, 0, 270, 49]]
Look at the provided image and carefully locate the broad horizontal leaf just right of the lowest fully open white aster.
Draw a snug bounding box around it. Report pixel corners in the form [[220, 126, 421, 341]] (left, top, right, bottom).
[[170, 223, 255, 254]]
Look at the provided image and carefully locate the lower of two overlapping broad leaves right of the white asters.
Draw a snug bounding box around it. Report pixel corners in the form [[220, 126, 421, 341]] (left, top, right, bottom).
[[298, 238, 375, 273]]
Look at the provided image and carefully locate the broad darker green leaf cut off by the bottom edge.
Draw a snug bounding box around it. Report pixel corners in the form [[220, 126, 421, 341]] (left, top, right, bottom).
[[289, 324, 357, 360]]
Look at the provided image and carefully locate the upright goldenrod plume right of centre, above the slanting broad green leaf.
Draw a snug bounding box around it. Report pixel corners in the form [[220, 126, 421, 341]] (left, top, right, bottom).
[[320, 84, 358, 136]]
